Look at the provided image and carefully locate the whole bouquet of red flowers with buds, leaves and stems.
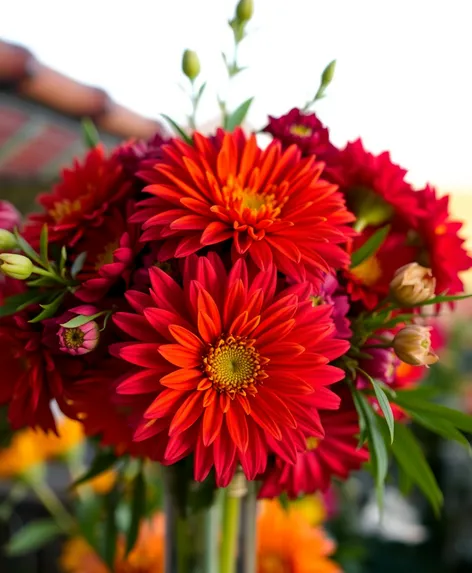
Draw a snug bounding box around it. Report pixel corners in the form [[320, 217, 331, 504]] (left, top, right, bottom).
[[0, 0, 472, 573]]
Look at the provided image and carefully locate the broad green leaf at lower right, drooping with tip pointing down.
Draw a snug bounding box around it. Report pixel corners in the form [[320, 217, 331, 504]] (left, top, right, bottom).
[[391, 423, 443, 514]]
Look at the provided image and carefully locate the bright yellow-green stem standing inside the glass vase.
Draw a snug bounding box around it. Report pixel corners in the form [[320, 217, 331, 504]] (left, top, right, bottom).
[[220, 473, 245, 573]]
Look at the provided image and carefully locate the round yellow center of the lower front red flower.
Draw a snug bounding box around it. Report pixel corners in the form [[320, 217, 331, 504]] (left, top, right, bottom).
[[203, 336, 268, 398]]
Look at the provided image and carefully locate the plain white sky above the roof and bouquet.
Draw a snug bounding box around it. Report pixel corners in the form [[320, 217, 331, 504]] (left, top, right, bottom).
[[0, 0, 472, 194]]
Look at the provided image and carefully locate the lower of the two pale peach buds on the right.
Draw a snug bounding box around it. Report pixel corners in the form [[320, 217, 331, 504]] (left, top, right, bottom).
[[393, 324, 439, 366]]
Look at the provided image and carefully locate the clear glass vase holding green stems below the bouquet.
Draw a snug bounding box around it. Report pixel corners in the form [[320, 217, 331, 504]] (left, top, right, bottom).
[[163, 465, 256, 573]]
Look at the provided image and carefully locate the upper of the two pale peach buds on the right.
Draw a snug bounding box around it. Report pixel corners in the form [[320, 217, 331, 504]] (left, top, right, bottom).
[[390, 263, 436, 306]]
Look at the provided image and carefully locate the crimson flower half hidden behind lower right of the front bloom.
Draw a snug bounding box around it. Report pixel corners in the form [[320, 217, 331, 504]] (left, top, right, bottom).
[[259, 391, 369, 499]]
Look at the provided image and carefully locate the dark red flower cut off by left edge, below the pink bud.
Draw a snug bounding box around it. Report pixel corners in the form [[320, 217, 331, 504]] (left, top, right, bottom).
[[0, 314, 62, 431]]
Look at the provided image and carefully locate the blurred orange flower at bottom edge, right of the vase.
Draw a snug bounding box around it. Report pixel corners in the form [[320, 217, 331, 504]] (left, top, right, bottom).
[[257, 500, 341, 573]]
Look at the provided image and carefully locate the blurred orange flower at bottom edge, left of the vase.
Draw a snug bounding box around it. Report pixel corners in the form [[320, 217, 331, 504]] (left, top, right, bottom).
[[59, 514, 164, 573]]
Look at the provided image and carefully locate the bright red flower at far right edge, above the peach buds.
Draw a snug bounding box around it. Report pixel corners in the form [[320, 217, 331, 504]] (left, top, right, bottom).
[[417, 185, 472, 294]]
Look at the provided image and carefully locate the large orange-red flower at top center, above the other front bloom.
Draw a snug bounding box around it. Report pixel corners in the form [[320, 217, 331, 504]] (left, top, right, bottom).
[[135, 129, 353, 290]]
